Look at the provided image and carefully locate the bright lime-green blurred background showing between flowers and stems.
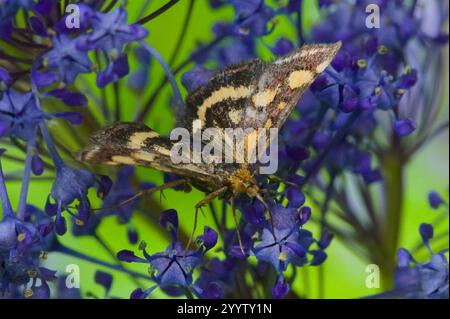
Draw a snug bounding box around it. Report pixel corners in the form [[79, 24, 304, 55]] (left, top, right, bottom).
[[4, 0, 449, 298]]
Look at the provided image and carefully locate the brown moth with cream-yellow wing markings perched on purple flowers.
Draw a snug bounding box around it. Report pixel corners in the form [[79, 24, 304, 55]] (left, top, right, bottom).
[[79, 42, 341, 248]]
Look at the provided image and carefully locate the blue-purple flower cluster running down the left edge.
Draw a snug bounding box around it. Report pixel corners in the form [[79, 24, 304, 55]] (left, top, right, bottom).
[[0, 0, 147, 298]]
